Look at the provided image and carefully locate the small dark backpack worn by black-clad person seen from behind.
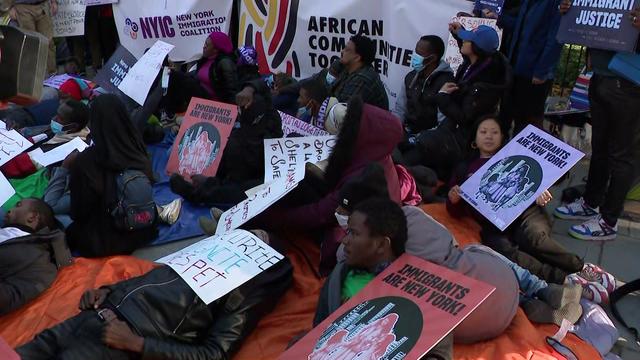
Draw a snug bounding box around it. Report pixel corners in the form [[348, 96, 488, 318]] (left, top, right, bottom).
[[111, 170, 158, 231]]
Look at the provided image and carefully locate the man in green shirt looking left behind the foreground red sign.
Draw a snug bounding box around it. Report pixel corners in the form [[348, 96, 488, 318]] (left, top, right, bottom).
[[313, 199, 453, 360]]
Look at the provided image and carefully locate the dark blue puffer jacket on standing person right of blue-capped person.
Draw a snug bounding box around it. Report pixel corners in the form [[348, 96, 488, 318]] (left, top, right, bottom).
[[498, 0, 562, 80]]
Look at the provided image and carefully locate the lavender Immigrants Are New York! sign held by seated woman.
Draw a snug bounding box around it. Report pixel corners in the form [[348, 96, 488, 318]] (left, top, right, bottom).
[[460, 125, 584, 230]]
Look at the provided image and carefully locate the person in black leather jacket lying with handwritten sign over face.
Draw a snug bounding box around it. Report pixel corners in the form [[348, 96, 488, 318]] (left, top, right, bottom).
[[16, 232, 293, 360]]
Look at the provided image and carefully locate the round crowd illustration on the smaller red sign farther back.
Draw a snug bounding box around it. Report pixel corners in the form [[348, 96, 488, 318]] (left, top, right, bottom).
[[178, 122, 220, 175]]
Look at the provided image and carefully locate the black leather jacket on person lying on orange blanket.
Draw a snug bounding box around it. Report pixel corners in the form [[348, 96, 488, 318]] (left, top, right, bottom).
[[104, 258, 293, 360]]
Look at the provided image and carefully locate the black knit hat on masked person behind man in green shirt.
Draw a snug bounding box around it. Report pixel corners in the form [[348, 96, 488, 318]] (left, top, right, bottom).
[[338, 163, 389, 212]]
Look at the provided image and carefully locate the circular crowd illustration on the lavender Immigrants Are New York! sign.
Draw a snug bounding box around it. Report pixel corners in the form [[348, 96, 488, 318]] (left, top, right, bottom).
[[476, 156, 542, 211]]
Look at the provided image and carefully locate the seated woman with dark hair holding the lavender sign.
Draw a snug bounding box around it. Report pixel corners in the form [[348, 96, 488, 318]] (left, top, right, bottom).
[[447, 115, 615, 303]]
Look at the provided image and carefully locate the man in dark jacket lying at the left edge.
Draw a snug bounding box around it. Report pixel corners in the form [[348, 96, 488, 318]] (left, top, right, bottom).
[[0, 198, 71, 315]]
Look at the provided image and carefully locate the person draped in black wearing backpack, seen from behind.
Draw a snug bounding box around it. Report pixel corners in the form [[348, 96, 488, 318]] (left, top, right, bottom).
[[65, 94, 157, 257]]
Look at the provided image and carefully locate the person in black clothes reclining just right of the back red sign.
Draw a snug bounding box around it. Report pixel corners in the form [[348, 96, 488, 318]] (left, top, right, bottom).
[[170, 91, 282, 207]]
